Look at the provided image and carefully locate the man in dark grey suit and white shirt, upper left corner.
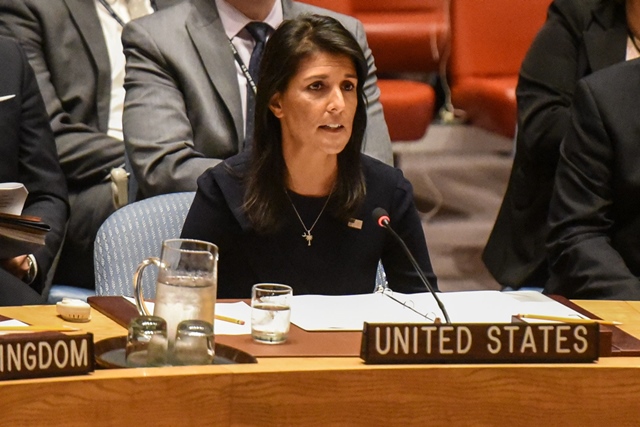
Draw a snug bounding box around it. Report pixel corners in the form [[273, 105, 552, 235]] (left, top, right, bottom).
[[0, 0, 176, 288]]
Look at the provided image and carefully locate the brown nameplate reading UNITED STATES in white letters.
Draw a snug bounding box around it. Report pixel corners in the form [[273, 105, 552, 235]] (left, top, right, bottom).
[[360, 322, 599, 364]]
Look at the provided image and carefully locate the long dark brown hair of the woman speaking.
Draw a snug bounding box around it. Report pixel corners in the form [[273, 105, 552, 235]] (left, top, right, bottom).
[[244, 15, 368, 233]]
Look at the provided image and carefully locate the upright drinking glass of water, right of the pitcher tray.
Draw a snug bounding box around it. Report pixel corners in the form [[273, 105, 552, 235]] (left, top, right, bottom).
[[251, 283, 293, 344]]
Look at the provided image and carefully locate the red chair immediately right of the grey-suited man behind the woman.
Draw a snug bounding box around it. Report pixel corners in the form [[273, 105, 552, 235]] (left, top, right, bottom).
[[345, 0, 448, 141]]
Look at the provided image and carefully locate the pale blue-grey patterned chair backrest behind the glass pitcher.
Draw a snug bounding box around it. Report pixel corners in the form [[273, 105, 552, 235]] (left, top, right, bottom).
[[94, 192, 195, 298]]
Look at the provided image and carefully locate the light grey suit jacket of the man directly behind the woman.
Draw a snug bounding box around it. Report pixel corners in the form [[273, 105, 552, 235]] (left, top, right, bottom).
[[122, 0, 392, 197]]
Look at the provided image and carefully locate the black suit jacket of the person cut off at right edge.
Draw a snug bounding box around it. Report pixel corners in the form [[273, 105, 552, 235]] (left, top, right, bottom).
[[546, 60, 640, 300]]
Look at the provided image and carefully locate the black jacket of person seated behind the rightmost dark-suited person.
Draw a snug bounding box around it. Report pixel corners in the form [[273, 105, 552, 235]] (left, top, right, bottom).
[[482, 0, 627, 288]]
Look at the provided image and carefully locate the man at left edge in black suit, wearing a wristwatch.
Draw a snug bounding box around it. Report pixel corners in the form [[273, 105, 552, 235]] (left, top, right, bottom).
[[0, 37, 69, 305]]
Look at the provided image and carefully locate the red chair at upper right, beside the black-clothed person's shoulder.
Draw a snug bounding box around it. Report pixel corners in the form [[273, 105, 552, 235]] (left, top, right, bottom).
[[449, 0, 551, 138]]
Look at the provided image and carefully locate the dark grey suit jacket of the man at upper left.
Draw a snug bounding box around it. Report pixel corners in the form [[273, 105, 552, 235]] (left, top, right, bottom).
[[0, 0, 176, 190]]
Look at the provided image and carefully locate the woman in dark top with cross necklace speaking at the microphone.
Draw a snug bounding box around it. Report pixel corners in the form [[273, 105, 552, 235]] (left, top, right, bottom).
[[182, 15, 436, 298]]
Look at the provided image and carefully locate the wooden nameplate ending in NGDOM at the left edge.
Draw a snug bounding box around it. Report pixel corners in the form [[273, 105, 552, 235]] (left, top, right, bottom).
[[0, 332, 94, 380]]
